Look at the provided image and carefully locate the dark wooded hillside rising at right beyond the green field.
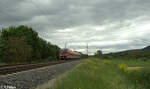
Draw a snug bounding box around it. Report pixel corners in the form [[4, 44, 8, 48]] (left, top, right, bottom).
[[101, 47, 150, 61]]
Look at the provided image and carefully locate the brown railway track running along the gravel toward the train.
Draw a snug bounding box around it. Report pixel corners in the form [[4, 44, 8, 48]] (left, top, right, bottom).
[[0, 60, 75, 75]]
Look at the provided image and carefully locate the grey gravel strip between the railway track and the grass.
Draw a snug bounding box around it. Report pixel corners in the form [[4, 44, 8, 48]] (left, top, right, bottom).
[[0, 60, 82, 89]]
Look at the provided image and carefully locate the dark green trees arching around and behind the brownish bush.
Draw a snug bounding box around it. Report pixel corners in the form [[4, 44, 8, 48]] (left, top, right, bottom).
[[0, 25, 60, 61]]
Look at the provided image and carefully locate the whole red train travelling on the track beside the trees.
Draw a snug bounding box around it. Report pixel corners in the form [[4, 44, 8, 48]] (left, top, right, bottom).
[[59, 49, 81, 59]]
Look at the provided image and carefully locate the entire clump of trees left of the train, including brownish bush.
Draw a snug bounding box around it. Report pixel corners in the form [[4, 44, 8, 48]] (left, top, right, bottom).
[[0, 25, 60, 63]]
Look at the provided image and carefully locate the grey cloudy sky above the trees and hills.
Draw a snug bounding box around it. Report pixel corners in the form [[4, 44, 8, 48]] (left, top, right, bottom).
[[0, 0, 150, 54]]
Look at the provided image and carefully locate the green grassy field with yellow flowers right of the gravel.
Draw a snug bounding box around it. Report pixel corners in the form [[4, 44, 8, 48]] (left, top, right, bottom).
[[39, 59, 150, 89]]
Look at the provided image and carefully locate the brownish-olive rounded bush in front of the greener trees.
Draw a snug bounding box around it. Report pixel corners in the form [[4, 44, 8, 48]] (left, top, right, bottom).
[[4, 37, 32, 63]]
